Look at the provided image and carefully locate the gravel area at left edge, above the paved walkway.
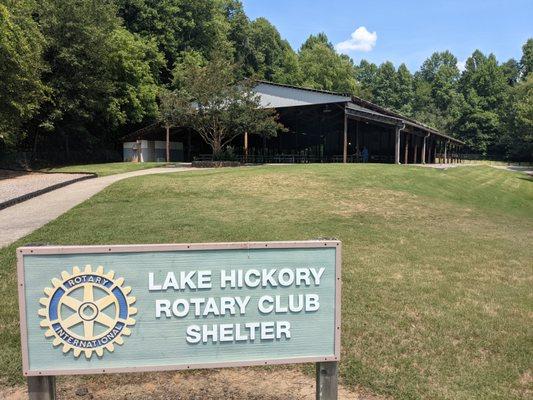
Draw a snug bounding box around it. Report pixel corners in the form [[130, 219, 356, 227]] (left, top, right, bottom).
[[0, 169, 90, 203]]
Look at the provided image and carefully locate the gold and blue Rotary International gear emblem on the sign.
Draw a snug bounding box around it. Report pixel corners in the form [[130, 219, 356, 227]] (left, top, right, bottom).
[[39, 265, 137, 359]]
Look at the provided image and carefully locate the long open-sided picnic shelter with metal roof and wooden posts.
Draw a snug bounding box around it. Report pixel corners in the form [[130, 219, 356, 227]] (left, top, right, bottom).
[[124, 81, 464, 164]]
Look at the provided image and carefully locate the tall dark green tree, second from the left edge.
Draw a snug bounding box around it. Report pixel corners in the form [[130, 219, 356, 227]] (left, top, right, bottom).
[[37, 0, 120, 158]]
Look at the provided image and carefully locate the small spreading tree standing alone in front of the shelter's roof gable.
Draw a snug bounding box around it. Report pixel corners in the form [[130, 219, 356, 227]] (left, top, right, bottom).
[[172, 55, 282, 157]]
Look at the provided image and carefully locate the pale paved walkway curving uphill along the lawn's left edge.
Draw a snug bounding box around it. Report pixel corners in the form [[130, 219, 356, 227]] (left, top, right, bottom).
[[0, 168, 192, 248]]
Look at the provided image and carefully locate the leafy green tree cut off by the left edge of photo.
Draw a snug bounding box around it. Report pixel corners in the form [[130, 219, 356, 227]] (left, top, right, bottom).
[[0, 0, 47, 144]]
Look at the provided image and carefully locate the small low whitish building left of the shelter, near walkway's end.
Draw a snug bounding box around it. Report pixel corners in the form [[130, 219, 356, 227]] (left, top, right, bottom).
[[122, 140, 183, 162]]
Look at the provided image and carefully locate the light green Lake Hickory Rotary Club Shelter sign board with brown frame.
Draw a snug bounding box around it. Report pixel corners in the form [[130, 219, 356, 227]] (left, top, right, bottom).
[[17, 241, 341, 376]]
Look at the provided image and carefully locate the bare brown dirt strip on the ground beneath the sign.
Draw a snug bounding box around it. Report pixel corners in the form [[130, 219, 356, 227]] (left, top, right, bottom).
[[0, 368, 383, 400]]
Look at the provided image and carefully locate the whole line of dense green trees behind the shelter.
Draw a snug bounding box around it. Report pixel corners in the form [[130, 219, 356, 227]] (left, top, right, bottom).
[[0, 0, 533, 161]]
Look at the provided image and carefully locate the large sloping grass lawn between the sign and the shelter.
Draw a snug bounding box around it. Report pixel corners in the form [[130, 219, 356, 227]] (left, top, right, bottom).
[[0, 164, 533, 399]]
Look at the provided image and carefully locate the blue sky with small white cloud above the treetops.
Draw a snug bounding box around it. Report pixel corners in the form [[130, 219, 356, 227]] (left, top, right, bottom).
[[243, 0, 533, 72]]
